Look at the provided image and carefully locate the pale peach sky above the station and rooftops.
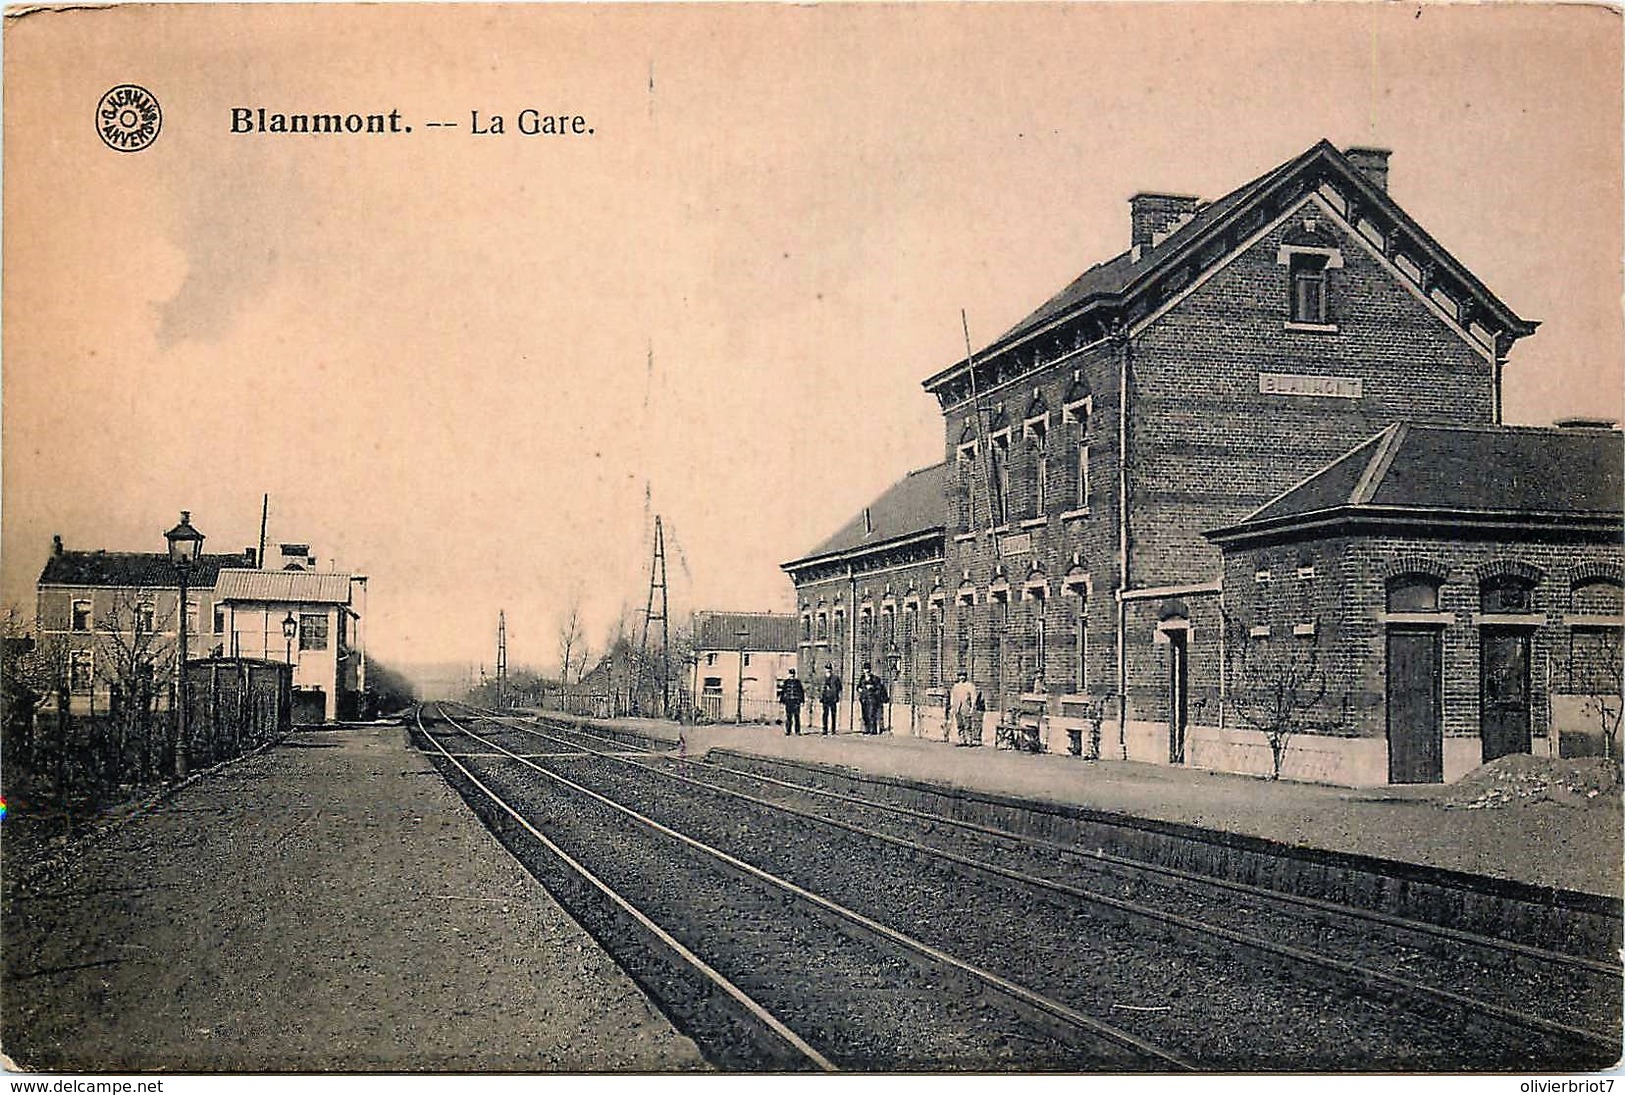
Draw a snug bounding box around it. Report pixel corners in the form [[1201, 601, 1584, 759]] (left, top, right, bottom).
[[0, 3, 1622, 666]]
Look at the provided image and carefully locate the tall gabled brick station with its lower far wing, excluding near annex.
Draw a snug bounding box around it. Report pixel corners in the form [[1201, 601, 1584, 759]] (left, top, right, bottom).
[[785, 141, 1619, 783]]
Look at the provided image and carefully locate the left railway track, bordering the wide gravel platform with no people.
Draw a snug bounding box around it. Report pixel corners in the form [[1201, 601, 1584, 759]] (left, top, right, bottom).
[[419, 698, 1190, 1071]]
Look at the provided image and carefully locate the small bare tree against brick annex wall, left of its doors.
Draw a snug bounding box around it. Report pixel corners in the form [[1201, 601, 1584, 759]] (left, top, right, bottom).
[[1229, 622, 1347, 780]]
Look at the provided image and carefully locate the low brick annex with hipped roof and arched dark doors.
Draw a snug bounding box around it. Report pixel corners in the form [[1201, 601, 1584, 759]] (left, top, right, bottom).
[[1209, 422, 1625, 785]]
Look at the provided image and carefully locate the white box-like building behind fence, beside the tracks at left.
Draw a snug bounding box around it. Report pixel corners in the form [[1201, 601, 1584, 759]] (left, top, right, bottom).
[[215, 569, 367, 723]]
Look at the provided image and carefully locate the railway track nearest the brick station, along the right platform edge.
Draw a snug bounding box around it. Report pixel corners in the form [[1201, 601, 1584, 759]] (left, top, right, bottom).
[[422, 698, 1619, 1069]]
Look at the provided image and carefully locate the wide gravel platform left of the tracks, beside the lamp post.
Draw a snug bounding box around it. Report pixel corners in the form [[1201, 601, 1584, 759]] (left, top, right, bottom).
[[0, 725, 707, 1072]]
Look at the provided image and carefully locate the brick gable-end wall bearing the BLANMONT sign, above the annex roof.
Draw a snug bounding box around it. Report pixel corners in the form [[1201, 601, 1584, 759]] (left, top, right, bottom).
[[1129, 205, 1495, 586]]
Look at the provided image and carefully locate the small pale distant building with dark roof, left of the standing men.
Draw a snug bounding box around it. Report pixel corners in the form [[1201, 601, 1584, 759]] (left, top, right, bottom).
[[691, 612, 796, 723]]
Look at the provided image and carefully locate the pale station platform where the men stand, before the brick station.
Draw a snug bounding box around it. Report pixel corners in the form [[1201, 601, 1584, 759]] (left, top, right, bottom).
[[546, 712, 1625, 898]]
